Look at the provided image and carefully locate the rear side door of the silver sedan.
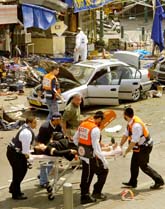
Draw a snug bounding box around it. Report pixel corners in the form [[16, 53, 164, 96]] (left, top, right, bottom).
[[111, 65, 141, 100]]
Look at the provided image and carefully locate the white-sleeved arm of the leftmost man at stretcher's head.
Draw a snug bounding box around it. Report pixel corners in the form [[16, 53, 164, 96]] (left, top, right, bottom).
[[19, 129, 32, 158]]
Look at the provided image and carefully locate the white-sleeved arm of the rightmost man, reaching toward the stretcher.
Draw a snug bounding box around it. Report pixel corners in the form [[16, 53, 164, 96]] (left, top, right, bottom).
[[123, 123, 143, 157]]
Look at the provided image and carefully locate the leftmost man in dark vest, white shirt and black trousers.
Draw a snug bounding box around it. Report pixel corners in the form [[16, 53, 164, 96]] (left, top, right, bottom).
[[7, 116, 37, 200]]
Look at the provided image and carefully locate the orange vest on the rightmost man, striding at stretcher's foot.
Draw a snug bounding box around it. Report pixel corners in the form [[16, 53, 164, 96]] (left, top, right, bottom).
[[127, 116, 150, 152]]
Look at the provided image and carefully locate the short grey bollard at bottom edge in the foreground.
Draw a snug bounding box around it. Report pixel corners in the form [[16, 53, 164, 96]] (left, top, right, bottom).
[[63, 183, 73, 209]]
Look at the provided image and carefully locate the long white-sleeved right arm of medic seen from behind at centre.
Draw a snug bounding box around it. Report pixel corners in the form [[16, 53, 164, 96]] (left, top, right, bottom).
[[91, 127, 108, 169]]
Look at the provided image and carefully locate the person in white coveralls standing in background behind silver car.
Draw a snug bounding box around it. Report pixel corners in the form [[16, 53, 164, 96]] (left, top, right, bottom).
[[74, 28, 88, 62]]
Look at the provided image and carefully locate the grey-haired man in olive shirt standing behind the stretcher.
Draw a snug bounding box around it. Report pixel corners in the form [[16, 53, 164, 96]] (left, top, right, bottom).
[[62, 94, 82, 139]]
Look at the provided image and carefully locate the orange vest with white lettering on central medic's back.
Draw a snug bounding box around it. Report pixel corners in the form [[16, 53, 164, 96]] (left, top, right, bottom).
[[78, 120, 97, 158]]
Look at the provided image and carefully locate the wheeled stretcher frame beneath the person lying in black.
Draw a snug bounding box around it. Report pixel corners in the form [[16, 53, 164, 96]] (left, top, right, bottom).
[[30, 154, 80, 200]]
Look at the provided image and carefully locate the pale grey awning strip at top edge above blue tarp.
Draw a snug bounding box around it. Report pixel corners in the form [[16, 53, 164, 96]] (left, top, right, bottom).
[[19, 0, 68, 12]]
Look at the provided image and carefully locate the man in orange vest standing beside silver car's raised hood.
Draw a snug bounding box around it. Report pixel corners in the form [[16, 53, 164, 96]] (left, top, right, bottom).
[[42, 64, 63, 120]]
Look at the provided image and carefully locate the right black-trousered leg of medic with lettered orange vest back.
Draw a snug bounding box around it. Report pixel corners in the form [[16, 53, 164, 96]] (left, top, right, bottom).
[[93, 159, 108, 195]]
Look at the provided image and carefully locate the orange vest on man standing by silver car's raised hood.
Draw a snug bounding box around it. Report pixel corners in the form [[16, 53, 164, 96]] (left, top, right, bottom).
[[42, 73, 61, 93]]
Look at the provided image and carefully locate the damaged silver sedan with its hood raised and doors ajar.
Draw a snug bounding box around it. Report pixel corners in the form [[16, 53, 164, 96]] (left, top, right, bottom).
[[28, 56, 152, 111]]
